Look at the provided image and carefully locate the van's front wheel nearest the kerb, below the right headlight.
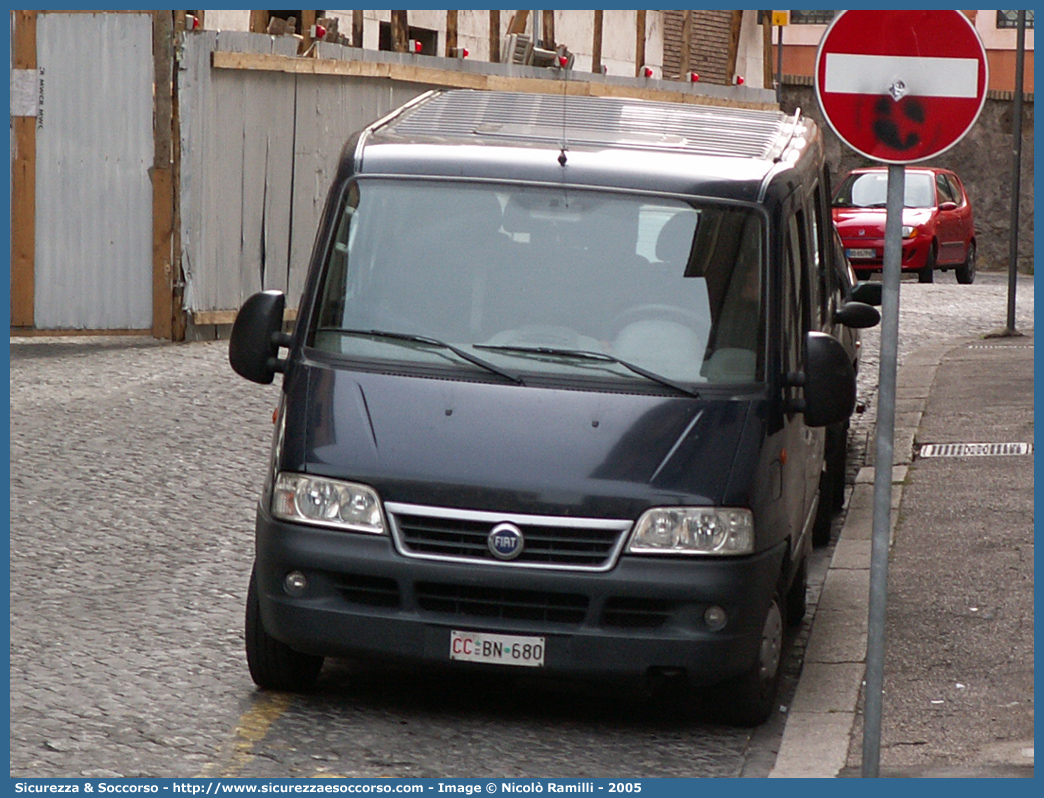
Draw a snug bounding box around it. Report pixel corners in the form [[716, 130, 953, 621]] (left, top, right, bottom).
[[714, 593, 786, 726]]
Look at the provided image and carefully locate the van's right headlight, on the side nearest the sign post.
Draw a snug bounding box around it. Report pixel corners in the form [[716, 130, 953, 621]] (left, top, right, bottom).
[[627, 507, 754, 555]]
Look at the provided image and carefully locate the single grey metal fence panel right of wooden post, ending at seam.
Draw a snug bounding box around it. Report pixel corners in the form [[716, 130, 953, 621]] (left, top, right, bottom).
[[179, 31, 296, 310]]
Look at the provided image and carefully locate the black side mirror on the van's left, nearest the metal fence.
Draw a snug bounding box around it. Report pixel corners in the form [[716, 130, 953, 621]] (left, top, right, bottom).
[[229, 290, 290, 385]]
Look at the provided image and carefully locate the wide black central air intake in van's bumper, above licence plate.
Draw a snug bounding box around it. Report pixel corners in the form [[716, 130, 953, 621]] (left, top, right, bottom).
[[414, 582, 588, 625]]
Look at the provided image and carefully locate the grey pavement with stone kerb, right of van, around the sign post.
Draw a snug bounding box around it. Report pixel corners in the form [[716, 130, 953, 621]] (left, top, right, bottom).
[[770, 332, 1034, 778]]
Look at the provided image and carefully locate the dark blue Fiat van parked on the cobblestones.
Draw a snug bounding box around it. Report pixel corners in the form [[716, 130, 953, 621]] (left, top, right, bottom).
[[230, 91, 877, 724]]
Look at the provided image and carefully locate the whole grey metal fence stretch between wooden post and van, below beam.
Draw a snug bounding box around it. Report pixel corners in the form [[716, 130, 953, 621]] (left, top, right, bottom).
[[179, 31, 427, 312]]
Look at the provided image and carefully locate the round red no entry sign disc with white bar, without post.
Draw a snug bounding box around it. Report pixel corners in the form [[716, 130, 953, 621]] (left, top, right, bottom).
[[815, 10, 989, 164]]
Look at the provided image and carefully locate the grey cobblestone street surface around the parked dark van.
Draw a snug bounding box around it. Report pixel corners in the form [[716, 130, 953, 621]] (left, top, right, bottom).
[[10, 274, 1034, 777]]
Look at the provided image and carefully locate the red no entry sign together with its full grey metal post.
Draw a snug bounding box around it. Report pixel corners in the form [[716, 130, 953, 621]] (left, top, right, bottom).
[[814, 10, 989, 778]]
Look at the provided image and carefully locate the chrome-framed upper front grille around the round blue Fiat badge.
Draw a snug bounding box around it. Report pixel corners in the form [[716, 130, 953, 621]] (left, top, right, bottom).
[[387, 504, 631, 570]]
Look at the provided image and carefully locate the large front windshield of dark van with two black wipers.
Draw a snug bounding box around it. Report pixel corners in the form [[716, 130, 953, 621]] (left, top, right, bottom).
[[310, 179, 764, 390]]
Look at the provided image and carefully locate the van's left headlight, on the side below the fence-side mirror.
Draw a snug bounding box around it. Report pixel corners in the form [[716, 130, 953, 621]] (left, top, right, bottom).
[[271, 472, 386, 535]]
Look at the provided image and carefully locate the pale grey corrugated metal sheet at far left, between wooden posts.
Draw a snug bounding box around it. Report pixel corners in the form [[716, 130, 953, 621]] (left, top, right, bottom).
[[33, 13, 153, 329]]
